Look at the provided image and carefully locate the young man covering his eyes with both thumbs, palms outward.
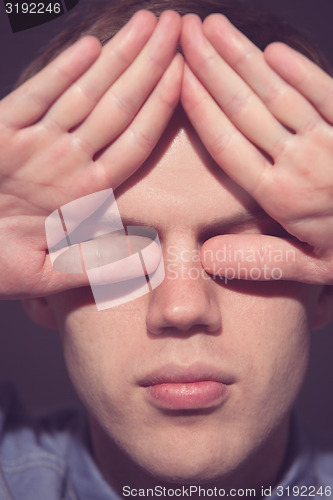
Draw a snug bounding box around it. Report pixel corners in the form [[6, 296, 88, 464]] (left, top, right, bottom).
[[0, 2, 333, 499]]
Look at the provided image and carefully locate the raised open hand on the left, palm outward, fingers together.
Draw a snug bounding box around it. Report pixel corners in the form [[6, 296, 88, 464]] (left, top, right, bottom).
[[0, 11, 183, 299]]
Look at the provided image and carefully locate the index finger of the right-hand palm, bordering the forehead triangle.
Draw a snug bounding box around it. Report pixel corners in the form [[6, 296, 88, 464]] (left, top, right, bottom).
[[181, 64, 271, 194]]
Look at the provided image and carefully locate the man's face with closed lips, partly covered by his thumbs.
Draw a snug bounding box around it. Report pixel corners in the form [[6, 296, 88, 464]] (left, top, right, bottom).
[[45, 114, 319, 484]]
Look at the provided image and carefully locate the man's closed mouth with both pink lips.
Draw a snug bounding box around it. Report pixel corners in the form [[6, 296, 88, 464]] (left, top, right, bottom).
[[139, 363, 233, 410]]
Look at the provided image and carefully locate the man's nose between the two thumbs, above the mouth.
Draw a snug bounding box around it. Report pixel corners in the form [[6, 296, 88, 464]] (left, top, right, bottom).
[[146, 240, 222, 335]]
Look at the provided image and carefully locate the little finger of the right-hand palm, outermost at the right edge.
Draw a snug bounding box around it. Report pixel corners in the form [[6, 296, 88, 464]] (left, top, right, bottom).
[[264, 42, 333, 124]]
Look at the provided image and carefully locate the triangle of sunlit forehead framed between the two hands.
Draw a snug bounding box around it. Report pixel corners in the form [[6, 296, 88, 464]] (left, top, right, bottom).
[[115, 114, 257, 231]]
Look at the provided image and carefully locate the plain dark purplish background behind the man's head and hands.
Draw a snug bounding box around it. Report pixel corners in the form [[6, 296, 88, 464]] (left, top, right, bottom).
[[0, 0, 333, 438]]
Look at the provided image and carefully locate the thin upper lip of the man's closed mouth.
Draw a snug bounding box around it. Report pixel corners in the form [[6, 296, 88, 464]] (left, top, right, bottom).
[[139, 362, 233, 387]]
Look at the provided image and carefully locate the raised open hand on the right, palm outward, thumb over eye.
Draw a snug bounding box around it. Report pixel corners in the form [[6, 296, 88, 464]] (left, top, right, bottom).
[[181, 14, 333, 284]]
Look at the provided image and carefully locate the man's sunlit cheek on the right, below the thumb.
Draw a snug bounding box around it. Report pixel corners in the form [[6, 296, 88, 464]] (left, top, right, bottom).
[[218, 282, 317, 420]]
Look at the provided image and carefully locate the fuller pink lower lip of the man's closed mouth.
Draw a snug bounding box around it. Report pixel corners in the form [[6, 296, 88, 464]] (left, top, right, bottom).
[[146, 380, 228, 410]]
